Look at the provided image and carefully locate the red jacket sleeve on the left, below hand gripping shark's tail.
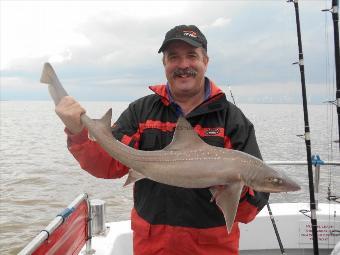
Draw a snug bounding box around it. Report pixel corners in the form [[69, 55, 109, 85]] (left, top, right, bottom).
[[65, 128, 128, 179]]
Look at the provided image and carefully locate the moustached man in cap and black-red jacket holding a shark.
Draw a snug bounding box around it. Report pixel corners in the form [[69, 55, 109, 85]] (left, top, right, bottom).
[[56, 25, 269, 255]]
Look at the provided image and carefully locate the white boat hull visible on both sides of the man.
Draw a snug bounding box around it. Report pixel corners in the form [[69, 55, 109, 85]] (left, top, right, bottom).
[[83, 203, 340, 255]]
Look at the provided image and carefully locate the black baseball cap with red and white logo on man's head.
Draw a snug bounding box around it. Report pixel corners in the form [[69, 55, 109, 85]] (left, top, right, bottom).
[[158, 25, 208, 53]]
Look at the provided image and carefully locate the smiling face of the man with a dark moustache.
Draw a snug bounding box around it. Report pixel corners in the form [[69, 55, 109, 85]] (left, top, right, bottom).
[[163, 41, 209, 99]]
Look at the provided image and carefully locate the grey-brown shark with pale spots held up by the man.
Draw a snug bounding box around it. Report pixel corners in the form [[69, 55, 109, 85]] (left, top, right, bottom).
[[40, 63, 300, 232]]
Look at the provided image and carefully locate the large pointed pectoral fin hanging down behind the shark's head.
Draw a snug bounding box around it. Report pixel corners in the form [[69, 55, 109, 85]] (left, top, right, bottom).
[[210, 182, 243, 233]]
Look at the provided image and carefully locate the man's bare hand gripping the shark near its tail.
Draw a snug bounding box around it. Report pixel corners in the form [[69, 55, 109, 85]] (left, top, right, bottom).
[[55, 96, 86, 134]]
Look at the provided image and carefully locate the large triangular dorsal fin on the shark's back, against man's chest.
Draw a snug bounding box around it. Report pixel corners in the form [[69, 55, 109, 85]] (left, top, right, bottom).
[[164, 117, 209, 151]]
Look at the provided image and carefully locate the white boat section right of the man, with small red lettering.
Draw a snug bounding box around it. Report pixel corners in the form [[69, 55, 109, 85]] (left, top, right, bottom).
[[240, 203, 340, 255]]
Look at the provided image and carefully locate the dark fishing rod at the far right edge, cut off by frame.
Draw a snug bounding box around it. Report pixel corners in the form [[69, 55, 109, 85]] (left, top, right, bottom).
[[322, 0, 340, 148]]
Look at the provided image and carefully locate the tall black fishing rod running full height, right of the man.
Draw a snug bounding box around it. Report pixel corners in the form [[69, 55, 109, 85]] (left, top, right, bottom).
[[287, 0, 319, 255]]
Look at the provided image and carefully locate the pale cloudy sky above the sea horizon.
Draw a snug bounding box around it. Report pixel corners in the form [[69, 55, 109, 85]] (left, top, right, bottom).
[[0, 0, 335, 103]]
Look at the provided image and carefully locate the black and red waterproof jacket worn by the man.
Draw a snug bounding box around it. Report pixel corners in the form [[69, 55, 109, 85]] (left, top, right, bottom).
[[68, 78, 269, 255]]
